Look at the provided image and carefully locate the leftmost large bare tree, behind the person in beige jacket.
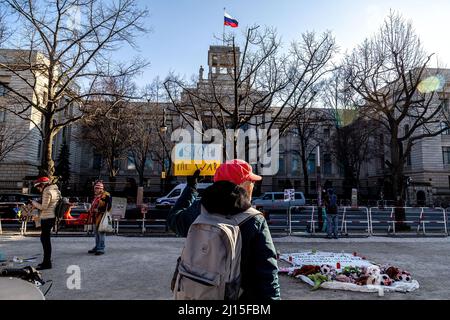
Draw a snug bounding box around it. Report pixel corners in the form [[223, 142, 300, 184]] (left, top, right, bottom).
[[0, 0, 148, 175]]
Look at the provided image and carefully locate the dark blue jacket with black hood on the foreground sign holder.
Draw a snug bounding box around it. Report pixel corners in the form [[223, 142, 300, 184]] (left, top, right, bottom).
[[167, 182, 280, 301]]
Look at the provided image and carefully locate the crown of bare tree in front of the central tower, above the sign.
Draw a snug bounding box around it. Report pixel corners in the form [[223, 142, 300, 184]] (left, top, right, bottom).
[[165, 26, 336, 158]]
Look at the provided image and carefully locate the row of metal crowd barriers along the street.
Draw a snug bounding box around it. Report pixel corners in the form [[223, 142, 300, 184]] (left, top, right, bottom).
[[0, 206, 450, 236]]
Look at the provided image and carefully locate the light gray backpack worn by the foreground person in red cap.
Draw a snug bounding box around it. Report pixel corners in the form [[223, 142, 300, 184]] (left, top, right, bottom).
[[172, 206, 261, 300]]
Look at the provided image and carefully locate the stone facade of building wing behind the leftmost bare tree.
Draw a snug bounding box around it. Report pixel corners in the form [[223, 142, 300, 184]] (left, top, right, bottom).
[[0, 49, 79, 191]]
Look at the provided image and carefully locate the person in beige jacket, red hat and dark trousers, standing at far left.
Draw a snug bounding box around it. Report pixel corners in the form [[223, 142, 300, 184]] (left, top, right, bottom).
[[32, 177, 61, 270]]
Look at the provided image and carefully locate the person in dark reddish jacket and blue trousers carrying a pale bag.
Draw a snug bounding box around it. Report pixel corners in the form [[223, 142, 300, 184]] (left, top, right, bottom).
[[88, 181, 112, 256]]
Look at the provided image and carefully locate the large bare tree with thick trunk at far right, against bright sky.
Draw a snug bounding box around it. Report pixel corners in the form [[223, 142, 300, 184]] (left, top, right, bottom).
[[345, 12, 445, 205]]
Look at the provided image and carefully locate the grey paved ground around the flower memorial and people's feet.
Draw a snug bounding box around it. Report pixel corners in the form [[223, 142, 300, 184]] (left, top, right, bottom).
[[0, 236, 450, 300]]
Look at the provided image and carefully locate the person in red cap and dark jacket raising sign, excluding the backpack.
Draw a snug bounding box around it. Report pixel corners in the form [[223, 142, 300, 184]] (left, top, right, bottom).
[[167, 159, 280, 301]]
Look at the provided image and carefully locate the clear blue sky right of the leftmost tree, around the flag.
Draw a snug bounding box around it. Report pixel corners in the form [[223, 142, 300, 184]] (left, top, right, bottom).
[[118, 0, 450, 85]]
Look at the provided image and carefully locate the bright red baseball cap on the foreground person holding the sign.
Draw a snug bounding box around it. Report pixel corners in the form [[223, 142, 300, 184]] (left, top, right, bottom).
[[214, 159, 262, 185]]
